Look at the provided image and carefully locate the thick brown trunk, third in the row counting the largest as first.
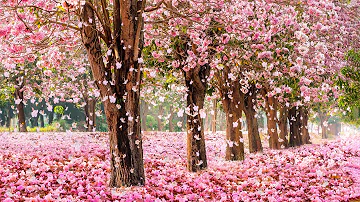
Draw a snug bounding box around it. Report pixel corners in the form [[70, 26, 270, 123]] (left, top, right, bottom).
[[222, 85, 244, 161]]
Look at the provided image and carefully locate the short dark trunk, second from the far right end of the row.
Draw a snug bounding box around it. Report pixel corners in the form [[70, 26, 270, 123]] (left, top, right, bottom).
[[288, 107, 302, 147]]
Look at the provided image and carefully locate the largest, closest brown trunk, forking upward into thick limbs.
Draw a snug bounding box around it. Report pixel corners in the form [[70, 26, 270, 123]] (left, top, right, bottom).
[[81, 0, 145, 187]]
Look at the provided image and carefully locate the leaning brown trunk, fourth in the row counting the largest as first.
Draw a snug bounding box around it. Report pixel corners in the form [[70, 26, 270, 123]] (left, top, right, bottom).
[[241, 86, 263, 153]]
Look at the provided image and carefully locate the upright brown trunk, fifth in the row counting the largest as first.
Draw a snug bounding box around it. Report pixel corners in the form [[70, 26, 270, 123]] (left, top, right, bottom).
[[266, 97, 280, 149]]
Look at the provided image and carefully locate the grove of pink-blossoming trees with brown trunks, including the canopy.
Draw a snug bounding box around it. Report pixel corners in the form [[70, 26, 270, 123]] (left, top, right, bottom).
[[0, 0, 360, 187]]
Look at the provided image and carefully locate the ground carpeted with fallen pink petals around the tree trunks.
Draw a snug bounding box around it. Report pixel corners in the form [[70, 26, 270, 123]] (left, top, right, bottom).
[[0, 132, 360, 202]]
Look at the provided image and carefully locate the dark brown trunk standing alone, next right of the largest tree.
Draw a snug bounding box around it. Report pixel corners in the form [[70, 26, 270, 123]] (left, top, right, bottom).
[[184, 65, 210, 172]]
